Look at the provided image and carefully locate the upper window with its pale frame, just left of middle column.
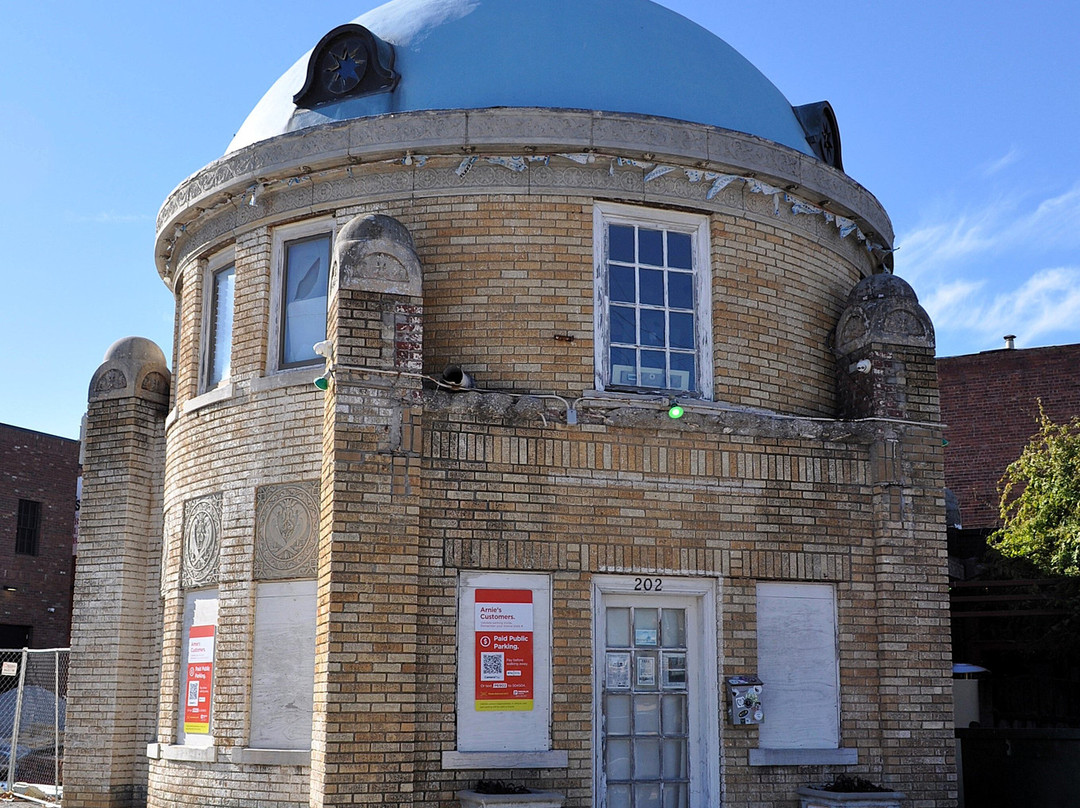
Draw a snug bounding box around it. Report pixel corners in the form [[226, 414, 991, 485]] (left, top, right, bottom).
[[269, 221, 333, 371]]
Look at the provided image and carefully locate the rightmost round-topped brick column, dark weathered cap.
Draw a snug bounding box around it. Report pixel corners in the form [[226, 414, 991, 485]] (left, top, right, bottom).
[[836, 274, 956, 806]]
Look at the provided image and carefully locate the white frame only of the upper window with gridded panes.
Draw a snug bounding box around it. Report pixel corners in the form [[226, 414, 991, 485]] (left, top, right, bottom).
[[593, 202, 713, 401]]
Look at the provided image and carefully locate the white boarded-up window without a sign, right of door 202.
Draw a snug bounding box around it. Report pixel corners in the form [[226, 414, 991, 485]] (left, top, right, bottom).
[[757, 583, 840, 749]]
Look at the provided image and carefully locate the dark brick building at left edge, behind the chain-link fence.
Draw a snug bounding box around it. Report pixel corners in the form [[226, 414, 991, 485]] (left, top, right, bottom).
[[0, 423, 79, 648]]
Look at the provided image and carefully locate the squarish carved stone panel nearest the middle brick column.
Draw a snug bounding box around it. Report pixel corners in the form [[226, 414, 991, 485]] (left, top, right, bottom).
[[255, 481, 319, 581]]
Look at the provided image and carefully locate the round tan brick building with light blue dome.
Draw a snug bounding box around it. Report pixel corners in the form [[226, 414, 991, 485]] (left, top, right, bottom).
[[65, 0, 955, 808]]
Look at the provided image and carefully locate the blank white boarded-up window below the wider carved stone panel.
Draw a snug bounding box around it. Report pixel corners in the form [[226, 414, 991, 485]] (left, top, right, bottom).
[[248, 580, 315, 750]]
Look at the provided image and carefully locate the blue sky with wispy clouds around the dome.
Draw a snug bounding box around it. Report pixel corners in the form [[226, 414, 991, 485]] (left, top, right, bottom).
[[0, 0, 1080, 437]]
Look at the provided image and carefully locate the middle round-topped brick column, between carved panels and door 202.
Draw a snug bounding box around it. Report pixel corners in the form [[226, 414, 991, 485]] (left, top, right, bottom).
[[311, 216, 421, 806]]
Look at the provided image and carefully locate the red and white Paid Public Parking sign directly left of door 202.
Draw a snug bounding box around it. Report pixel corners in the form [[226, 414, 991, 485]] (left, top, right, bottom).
[[475, 589, 534, 712]]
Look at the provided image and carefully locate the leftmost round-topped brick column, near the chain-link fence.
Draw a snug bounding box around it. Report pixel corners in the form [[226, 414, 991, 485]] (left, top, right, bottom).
[[64, 337, 170, 808]]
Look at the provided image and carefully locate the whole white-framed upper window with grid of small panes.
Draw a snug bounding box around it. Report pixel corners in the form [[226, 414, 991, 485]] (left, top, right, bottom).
[[594, 204, 713, 399]]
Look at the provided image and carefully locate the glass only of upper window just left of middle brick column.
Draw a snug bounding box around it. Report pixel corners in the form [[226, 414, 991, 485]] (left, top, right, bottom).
[[278, 233, 330, 367]]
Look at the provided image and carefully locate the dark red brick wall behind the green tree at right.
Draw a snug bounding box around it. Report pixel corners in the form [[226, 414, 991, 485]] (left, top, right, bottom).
[[937, 345, 1080, 529]]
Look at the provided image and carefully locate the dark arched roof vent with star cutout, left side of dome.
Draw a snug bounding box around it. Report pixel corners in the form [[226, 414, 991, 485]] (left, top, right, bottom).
[[293, 23, 401, 109]]
